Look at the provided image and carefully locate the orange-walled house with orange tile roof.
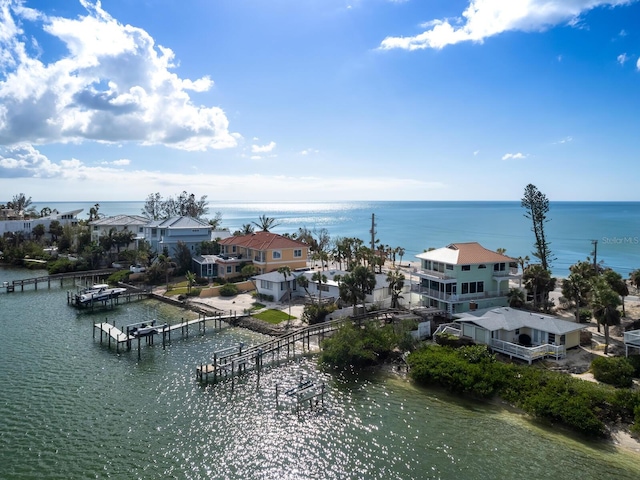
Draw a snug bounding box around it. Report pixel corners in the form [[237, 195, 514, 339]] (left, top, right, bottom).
[[194, 231, 309, 278]]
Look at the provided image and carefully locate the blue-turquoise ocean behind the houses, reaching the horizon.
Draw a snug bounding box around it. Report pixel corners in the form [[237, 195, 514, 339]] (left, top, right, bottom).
[[41, 201, 640, 278]]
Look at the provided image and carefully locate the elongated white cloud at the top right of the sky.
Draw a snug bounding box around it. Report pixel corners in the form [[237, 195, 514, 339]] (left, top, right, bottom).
[[380, 0, 636, 50]]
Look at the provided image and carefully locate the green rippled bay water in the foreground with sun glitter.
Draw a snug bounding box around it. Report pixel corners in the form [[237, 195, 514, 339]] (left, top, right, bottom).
[[0, 268, 640, 480]]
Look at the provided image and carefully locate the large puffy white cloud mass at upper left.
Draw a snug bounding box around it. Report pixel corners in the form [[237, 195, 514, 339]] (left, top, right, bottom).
[[0, 0, 237, 151]]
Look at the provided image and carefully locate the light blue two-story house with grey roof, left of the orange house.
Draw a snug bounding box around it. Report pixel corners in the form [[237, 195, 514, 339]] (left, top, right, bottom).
[[144, 216, 211, 255]]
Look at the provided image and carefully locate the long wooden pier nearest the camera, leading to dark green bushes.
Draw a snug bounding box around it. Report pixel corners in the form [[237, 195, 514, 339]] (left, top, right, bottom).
[[196, 317, 352, 383]]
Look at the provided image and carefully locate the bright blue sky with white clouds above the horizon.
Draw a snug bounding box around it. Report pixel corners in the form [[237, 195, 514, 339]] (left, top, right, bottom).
[[0, 0, 640, 203]]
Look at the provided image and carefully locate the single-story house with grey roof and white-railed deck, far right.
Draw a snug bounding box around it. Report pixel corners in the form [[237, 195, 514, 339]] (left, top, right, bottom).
[[455, 307, 586, 363]]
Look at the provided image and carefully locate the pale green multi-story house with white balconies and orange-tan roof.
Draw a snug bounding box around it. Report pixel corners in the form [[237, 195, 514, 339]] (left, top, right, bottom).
[[412, 242, 521, 317]]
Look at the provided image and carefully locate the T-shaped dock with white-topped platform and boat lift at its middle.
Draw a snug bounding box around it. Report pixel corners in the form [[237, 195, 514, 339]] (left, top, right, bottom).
[[93, 312, 246, 360]]
